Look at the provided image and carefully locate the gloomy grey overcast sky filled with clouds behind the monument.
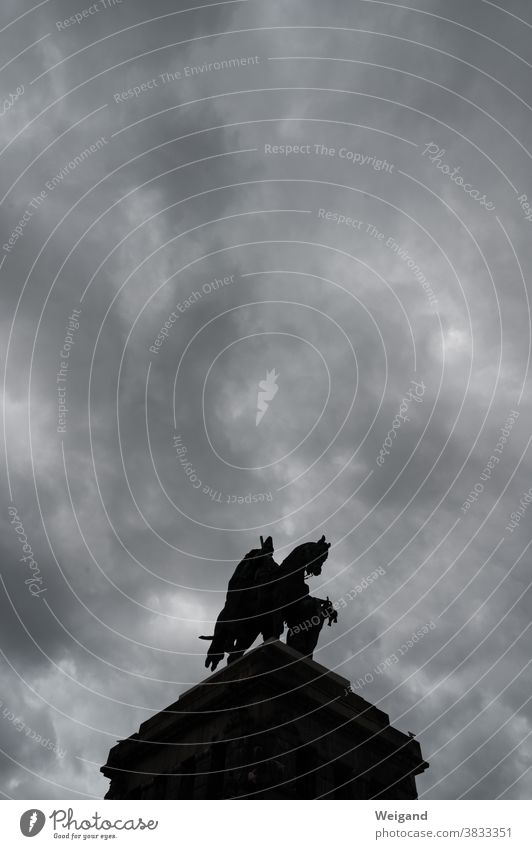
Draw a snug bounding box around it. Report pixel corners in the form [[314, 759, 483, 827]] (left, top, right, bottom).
[[0, 0, 532, 799]]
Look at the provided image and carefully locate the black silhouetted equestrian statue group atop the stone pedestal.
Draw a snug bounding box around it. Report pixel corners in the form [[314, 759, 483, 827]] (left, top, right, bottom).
[[200, 536, 338, 671]]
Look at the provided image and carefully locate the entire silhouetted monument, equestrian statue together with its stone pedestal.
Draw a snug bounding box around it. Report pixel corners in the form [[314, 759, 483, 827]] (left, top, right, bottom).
[[101, 537, 428, 799]]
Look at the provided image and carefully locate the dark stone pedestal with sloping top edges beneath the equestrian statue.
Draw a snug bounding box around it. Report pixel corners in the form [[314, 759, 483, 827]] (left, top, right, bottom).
[[101, 640, 428, 799]]
